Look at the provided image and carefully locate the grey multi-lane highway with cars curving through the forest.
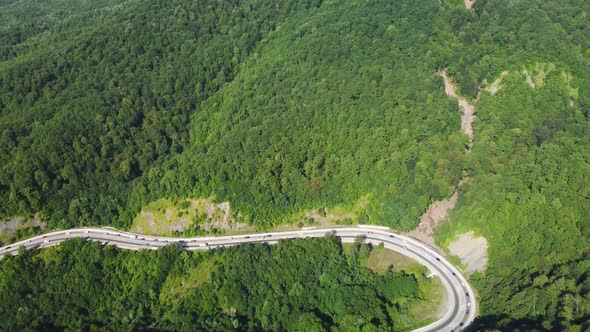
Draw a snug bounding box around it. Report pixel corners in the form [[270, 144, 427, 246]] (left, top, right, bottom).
[[0, 225, 477, 332]]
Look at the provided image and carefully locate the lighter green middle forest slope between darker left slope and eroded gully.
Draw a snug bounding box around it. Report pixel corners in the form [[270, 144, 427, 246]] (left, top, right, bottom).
[[155, 1, 464, 229]]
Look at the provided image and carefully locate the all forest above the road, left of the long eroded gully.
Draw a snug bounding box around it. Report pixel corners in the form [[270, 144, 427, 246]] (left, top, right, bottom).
[[0, 1, 472, 228]]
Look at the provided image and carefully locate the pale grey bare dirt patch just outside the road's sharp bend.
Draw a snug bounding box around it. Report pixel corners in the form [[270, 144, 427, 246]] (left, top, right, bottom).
[[449, 231, 488, 275]]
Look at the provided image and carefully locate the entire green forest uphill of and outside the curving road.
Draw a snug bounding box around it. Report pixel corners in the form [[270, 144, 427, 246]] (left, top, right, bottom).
[[0, 0, 590, 331]]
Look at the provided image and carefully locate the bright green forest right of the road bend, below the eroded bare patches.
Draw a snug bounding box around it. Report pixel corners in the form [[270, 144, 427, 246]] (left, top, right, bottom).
[[439, 73, 590, 330]]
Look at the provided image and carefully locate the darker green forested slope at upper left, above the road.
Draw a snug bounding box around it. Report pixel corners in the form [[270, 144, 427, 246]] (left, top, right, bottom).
[[0, 1, 326, 227]]
